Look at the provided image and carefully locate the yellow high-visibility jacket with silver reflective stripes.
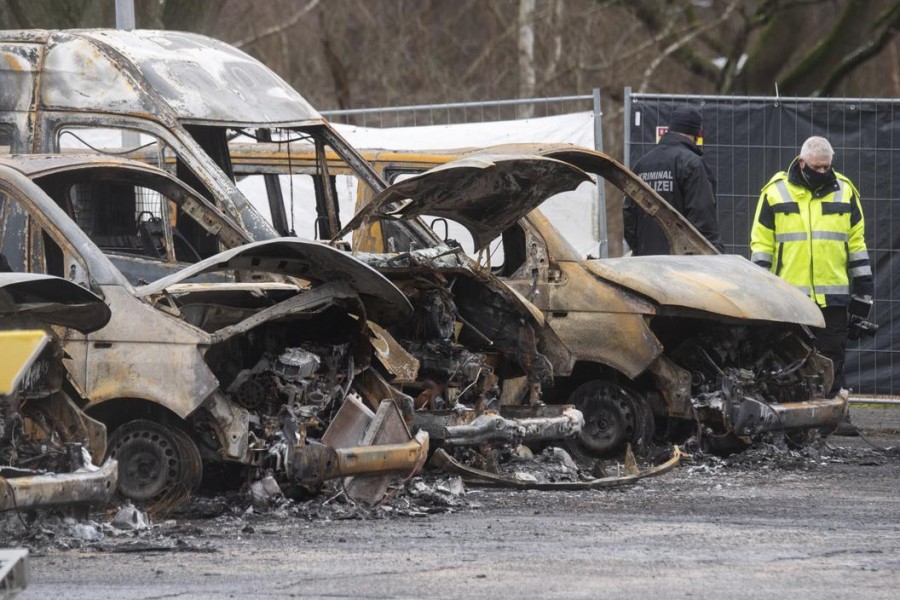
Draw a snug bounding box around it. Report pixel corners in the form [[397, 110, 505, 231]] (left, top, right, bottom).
[[750, 160, 873, 306]]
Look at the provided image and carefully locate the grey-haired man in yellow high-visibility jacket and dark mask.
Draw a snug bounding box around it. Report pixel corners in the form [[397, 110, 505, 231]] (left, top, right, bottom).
[[750, 136, 874, 435]]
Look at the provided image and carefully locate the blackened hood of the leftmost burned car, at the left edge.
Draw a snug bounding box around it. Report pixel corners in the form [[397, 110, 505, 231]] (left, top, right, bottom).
[[0, 273, 112, 333]]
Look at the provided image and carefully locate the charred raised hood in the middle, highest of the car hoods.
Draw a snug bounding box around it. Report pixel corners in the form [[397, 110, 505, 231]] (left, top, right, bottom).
[[336, 154, 591, 250]]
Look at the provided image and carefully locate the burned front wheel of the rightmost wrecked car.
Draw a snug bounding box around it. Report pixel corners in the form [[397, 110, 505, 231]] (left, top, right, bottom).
[[566, 380, 653, 460]]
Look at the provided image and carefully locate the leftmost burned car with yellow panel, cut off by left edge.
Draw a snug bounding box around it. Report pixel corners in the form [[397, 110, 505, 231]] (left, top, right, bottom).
[[0, 272, 118, 511]]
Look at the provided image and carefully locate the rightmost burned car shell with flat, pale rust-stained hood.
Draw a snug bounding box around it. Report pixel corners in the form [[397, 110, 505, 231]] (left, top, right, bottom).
[[361, 146, 846, 455]]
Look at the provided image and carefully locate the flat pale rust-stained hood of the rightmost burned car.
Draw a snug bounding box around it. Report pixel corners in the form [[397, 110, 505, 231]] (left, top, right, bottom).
[[584, 255, 825, 327]]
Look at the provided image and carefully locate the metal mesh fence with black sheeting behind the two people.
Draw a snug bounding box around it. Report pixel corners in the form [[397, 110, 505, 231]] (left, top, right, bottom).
[[625, 90, 900, 395]]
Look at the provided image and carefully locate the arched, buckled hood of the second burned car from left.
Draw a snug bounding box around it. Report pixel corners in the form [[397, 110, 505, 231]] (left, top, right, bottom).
[[136, 238, 413, 325]]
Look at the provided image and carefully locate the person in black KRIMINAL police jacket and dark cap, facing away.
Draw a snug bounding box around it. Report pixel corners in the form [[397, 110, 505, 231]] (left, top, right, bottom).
[[622, 105, 723, 256]]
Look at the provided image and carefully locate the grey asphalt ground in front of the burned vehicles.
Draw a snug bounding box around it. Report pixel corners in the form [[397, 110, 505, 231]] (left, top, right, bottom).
[[8, 405, 900, 600]]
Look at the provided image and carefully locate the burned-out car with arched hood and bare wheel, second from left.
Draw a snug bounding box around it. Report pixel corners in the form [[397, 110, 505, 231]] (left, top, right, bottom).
[[0, 155, 428, 502]]
